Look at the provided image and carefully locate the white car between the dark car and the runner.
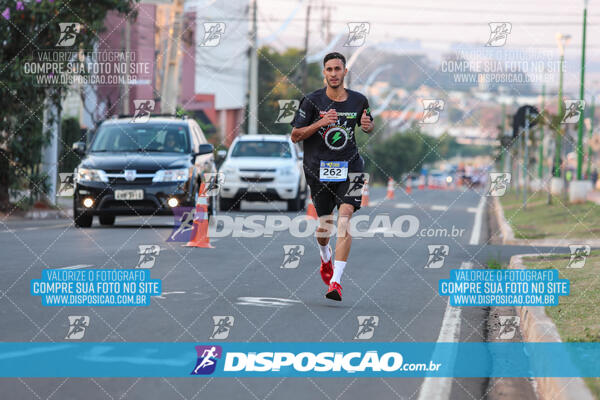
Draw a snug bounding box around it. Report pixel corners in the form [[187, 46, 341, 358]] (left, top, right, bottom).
[[219, 135, 308, 211]]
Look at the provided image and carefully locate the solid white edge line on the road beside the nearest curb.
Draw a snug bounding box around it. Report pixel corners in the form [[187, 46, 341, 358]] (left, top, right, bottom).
[[418, 262, 473, 400]]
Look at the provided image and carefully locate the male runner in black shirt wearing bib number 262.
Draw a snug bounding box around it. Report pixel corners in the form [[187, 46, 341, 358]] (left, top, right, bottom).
[[291, 53, 374, 301]]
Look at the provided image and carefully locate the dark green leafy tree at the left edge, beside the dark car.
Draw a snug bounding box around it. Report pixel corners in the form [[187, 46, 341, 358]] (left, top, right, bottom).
[[0, 0, 137, 209]]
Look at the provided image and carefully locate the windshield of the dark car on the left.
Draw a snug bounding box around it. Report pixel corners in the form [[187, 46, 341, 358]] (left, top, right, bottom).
[[91, 123, 190, 153]]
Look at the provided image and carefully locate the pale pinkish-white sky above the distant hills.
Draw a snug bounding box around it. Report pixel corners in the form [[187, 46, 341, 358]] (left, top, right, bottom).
[[258, 0, 600, 95]]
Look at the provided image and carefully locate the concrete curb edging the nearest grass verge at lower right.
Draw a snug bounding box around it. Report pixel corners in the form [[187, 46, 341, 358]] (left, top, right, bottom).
[[509, 254, 595, 400]]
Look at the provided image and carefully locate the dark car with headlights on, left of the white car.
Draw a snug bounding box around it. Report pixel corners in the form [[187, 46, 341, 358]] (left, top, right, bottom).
[[73, 117, 218, 227]]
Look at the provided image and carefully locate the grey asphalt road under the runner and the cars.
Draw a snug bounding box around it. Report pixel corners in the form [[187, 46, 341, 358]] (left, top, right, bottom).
[[0, 188, 558, 400]]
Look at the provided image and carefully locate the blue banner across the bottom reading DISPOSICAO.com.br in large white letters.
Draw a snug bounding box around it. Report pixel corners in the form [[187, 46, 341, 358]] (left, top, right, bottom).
[[0, 342, 600, 378]]
